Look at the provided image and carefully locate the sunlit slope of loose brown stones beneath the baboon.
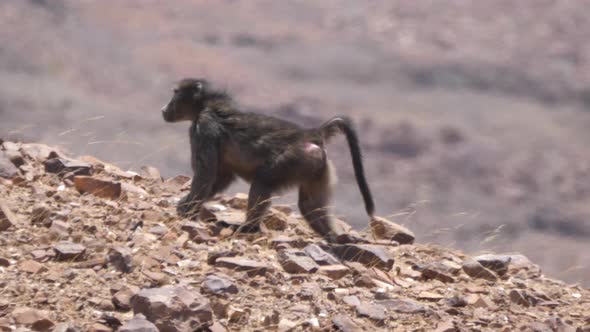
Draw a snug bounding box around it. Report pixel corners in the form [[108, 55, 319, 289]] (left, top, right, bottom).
[[0, 142, 590, 332]]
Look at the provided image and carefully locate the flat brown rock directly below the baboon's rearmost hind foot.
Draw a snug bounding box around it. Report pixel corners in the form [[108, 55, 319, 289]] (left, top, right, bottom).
[[333, 244, 394, 271]]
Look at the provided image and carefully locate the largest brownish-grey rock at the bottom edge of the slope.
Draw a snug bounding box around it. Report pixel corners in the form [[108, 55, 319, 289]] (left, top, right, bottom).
[[131, 286, 213, 332]]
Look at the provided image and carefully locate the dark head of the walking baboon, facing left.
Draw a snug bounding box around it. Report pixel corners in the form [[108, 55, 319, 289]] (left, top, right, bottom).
[[162, 78, 208, 122]]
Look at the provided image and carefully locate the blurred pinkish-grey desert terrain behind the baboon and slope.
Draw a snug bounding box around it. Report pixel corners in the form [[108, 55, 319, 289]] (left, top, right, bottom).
[[0, 0, 590, 286]]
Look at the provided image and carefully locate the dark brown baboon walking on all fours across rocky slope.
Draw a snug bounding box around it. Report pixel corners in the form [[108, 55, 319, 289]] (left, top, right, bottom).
[[162, 78, 375, 239]]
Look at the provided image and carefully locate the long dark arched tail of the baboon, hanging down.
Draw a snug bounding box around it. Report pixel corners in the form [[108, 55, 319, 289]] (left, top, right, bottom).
[[319, 116, 375, 217]]
